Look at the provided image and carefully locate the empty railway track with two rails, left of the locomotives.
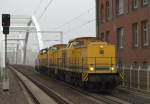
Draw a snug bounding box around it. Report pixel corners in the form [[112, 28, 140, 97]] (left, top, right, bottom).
[[10, 67, 72, 104]]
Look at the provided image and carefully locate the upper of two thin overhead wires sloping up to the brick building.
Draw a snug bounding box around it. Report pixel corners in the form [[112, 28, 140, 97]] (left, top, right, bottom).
[[53, 6, 95, 30]]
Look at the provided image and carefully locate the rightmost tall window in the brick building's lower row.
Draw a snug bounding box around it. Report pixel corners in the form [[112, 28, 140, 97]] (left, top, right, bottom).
[[142, 21, 148, 46]]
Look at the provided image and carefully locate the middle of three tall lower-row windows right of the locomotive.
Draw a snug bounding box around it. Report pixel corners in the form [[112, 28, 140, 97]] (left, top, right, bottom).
[[132, 23, 139, 47]]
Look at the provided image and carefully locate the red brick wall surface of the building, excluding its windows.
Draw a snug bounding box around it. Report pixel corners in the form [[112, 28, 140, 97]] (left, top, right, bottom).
[[97, 0, 150, 64]]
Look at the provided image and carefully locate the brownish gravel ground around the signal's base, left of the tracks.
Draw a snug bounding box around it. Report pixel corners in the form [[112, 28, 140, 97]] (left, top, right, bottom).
[[0, 70, 28, 104]]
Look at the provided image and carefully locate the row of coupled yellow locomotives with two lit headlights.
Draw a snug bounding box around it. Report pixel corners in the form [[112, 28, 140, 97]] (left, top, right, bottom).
[[35, 37, 121, 90]]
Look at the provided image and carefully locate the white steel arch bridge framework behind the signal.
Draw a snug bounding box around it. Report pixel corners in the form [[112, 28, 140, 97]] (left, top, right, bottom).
[[0, 15, 43, 67]]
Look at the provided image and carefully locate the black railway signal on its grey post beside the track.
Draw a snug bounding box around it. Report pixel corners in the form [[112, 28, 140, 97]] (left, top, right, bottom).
[[2, 14, 10, 91]]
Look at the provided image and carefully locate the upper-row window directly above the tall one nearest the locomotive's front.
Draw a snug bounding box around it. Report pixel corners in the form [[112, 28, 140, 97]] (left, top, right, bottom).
[[116, 0, 124, 15]]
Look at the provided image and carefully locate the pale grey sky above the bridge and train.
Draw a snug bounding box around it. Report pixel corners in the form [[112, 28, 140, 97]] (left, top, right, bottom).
[[0, 0, 95, 47]]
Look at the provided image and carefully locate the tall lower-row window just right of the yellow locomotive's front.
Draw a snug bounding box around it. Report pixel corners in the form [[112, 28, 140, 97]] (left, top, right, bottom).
[[117, 27, 124, 48]]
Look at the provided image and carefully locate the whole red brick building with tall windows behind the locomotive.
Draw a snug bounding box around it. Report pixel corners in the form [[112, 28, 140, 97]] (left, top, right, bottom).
[[96, 0, 150, 65]]
